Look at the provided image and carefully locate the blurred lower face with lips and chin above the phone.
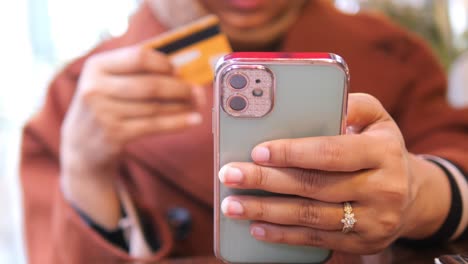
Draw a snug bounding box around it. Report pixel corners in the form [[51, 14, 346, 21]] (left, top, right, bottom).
[[199, 0, 306, 49]]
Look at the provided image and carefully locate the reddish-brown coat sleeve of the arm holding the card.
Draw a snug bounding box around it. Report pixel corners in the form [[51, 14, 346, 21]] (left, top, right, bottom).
[[20, 67, 172, 264]]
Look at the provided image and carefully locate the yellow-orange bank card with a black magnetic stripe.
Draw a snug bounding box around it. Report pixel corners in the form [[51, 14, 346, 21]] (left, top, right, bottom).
[[148, 15, 232, 85]]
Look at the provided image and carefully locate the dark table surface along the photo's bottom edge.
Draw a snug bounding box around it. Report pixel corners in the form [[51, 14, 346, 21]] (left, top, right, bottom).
[[161, 240, 468, 264]]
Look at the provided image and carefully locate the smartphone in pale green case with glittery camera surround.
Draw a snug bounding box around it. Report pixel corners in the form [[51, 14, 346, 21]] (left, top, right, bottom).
[[213, 52, 349, 263]]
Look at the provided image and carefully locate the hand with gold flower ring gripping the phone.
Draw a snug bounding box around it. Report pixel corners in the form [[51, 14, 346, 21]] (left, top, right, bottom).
[[219, 94, 450, 254]]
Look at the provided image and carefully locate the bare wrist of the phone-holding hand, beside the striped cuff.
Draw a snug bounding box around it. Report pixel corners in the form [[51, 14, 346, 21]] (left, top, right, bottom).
[[401, 154, 451, 240]]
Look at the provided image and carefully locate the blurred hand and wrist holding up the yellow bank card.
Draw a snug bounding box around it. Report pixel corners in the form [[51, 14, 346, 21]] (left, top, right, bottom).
[[60, 46, 204, 229]]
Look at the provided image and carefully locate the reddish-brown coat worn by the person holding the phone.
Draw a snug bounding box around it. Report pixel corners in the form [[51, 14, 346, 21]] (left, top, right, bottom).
[[21, 1, 468, 264]]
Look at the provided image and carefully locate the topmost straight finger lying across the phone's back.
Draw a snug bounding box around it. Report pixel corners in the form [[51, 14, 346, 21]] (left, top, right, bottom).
[[252, 135, 382, 171]]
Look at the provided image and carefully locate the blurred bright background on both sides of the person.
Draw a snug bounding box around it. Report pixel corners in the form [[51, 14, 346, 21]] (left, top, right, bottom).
[[0, 0, 468, 264]]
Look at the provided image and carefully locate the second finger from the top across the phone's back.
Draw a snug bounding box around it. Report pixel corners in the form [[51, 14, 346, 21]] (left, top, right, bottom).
[[218, 162, 362, 203]]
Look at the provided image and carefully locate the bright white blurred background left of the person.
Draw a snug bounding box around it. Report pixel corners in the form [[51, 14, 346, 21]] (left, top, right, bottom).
[[0, 0, 136, 264]]
